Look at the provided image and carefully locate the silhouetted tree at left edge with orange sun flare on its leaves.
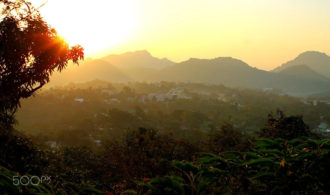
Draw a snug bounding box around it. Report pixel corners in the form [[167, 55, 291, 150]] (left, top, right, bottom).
[[0, 0, 84, 126]]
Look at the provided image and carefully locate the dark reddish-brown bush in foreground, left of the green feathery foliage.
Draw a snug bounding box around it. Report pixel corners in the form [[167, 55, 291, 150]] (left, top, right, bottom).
[[97, 128, 198, 192]]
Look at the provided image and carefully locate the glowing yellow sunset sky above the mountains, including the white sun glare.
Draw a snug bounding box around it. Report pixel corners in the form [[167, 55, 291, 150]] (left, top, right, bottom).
[[31, 0, 330, 70]]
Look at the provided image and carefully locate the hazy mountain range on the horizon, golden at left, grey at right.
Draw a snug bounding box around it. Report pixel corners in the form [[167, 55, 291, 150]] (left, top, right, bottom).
[[47, 50, 330, 96]]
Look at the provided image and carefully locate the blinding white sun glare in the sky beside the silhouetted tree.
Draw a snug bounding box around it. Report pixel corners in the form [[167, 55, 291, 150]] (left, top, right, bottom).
[[31, 0, 137, 55]]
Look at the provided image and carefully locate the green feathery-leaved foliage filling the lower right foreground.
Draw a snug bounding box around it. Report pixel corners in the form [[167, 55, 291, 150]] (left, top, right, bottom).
[[140, 137, 330, 194]]
